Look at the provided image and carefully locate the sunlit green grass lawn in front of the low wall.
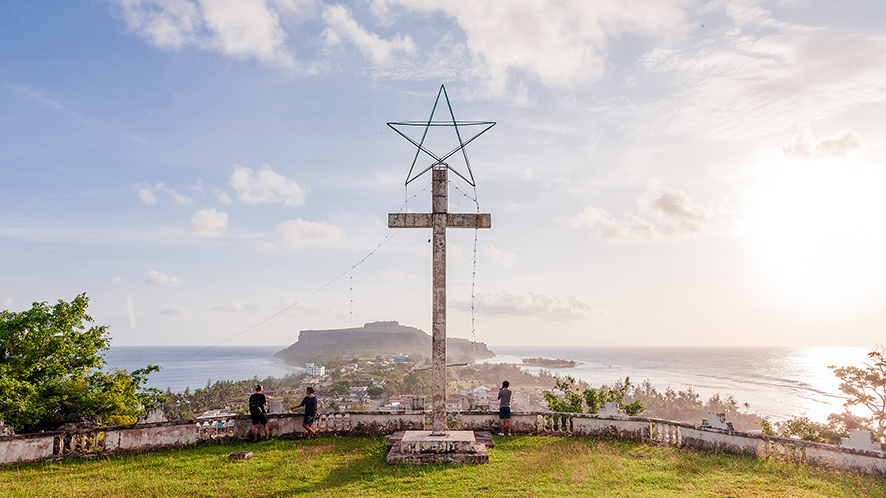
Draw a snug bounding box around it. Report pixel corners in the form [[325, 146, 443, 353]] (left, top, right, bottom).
[[0, 436, 886, 498]]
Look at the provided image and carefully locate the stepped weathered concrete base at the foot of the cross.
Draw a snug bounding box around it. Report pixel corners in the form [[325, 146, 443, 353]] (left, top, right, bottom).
[[387, 431, 492, 465]]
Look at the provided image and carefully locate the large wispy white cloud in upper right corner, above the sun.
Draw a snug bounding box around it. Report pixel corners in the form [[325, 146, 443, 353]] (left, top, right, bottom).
[[643, 6, 886, 140]]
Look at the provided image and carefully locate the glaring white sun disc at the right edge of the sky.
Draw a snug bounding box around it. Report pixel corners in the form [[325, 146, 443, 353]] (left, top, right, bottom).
[[749, 160, 886, 299]]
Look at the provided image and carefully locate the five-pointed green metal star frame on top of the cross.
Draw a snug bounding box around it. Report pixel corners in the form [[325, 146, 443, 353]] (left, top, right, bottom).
[[388, 85, 495, 187]]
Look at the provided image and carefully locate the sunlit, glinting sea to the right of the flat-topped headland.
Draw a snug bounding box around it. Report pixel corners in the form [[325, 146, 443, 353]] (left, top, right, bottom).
[[485, 346, 869, 421]]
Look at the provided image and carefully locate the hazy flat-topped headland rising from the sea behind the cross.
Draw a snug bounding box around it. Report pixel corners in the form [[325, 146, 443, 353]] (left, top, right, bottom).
[[274, 321, 495, 366]]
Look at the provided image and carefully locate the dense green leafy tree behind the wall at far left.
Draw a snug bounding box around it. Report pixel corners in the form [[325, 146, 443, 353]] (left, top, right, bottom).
[[0, 294, 163, 432]]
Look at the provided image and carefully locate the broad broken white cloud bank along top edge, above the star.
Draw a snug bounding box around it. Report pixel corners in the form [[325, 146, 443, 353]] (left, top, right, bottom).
[[113, 0, 687, 90]]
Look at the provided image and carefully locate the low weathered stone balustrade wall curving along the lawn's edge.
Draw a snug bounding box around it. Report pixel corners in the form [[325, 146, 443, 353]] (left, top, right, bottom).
[[0, 411, 886, 475]]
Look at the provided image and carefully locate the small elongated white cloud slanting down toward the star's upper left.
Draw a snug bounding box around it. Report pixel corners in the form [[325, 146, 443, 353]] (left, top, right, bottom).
[[323, 5, 416, 66]]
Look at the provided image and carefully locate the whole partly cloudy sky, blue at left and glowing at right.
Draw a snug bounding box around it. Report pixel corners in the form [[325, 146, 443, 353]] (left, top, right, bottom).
[[0, 0, 886, 347]]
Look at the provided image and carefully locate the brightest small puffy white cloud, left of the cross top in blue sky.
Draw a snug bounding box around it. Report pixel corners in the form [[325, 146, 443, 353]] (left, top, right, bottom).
[[228, 164, 310, 206]]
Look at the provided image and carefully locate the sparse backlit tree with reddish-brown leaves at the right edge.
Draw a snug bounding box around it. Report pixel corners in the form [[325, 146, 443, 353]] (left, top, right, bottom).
[[828, 346, 886, 440]]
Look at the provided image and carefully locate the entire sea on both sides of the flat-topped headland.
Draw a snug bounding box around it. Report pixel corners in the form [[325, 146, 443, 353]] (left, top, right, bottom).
[[105, 346, 868, 421]]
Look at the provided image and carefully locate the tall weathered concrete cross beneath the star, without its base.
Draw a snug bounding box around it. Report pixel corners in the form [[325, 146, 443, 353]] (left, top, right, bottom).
[[388, 163, 492, 435]]
